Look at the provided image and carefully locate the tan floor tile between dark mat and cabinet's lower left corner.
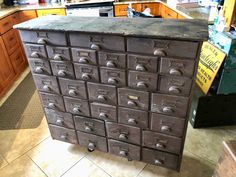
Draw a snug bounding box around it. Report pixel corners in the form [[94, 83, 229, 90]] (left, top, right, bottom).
[[0, 118, 49, 162]]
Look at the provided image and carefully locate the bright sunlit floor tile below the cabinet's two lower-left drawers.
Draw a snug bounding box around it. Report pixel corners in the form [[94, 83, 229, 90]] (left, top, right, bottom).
[[27, 138, 87, 177]]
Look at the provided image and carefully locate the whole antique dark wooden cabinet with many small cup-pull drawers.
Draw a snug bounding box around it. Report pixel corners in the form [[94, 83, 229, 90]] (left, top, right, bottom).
[[16, 17, 208, 170]]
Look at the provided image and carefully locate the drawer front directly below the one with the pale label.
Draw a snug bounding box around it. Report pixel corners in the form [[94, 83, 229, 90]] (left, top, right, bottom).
[[118, 107, 148, 128]]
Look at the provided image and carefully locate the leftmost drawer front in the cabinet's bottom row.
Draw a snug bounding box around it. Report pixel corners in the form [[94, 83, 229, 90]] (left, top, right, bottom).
[[48, 124, 78, 144]]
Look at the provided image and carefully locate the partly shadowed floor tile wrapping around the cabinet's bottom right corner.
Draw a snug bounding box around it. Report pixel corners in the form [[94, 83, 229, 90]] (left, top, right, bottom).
[[138, 151, 215, 177]]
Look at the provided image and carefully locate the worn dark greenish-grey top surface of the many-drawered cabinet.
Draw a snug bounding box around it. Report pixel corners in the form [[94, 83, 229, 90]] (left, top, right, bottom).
[[14, 15, 208, 41]]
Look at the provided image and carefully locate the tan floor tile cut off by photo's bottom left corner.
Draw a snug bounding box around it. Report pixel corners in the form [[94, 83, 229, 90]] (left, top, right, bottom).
[[0, 155, 46, 177]]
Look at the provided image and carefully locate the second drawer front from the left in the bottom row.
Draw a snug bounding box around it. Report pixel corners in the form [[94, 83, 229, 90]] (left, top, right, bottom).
[[77, 131, 107, 152]]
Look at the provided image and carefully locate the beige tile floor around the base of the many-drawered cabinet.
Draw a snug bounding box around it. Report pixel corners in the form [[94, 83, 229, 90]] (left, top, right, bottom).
[[0, 68, 236, 177]]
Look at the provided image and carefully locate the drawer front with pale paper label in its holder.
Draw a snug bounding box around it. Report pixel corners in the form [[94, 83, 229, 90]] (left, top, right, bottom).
[[118, 88, 149, 110]]
